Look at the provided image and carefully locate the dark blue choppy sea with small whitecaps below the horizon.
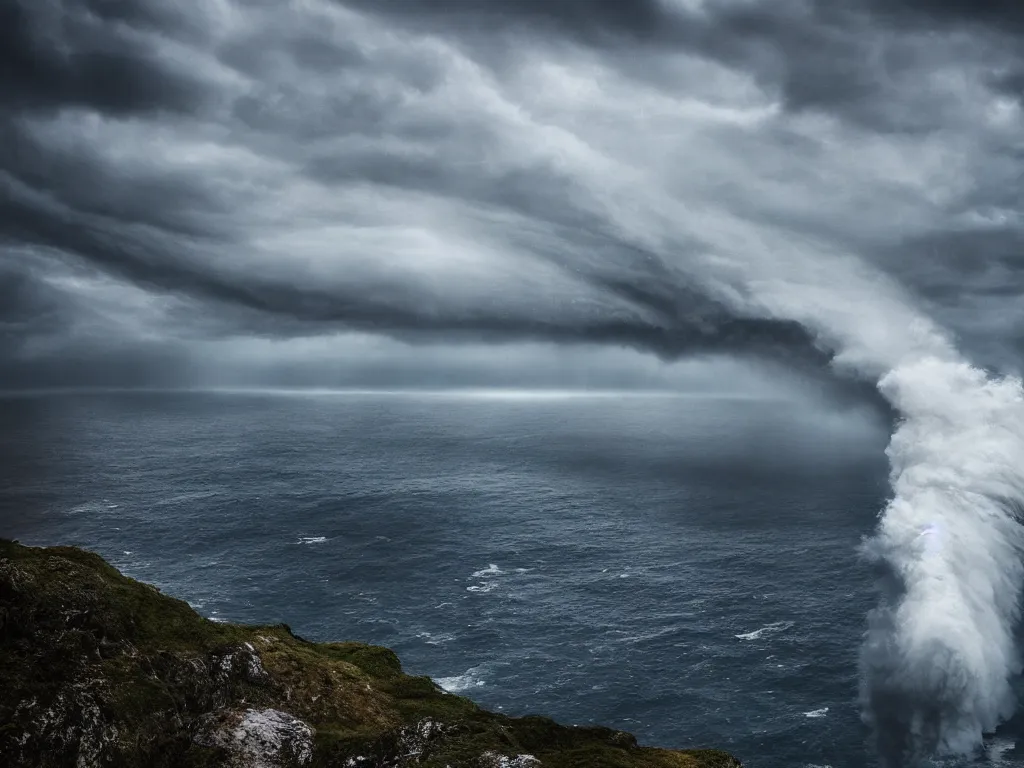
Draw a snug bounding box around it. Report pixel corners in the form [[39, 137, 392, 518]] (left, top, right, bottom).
[[0, 392, 1015, 768]]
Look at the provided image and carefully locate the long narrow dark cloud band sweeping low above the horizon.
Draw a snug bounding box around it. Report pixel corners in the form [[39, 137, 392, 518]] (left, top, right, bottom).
[[0, 167, 818, 359]]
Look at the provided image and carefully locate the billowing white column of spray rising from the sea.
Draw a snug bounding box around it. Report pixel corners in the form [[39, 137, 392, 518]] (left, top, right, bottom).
[[861, 356, 1024, 765]]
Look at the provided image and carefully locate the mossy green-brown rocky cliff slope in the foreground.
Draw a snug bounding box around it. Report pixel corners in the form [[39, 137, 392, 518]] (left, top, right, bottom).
[[0, 540, 739, 768]]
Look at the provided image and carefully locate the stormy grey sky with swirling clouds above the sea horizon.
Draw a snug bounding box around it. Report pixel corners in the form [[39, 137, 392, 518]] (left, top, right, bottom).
[[0, 0, 1024, 388]]
